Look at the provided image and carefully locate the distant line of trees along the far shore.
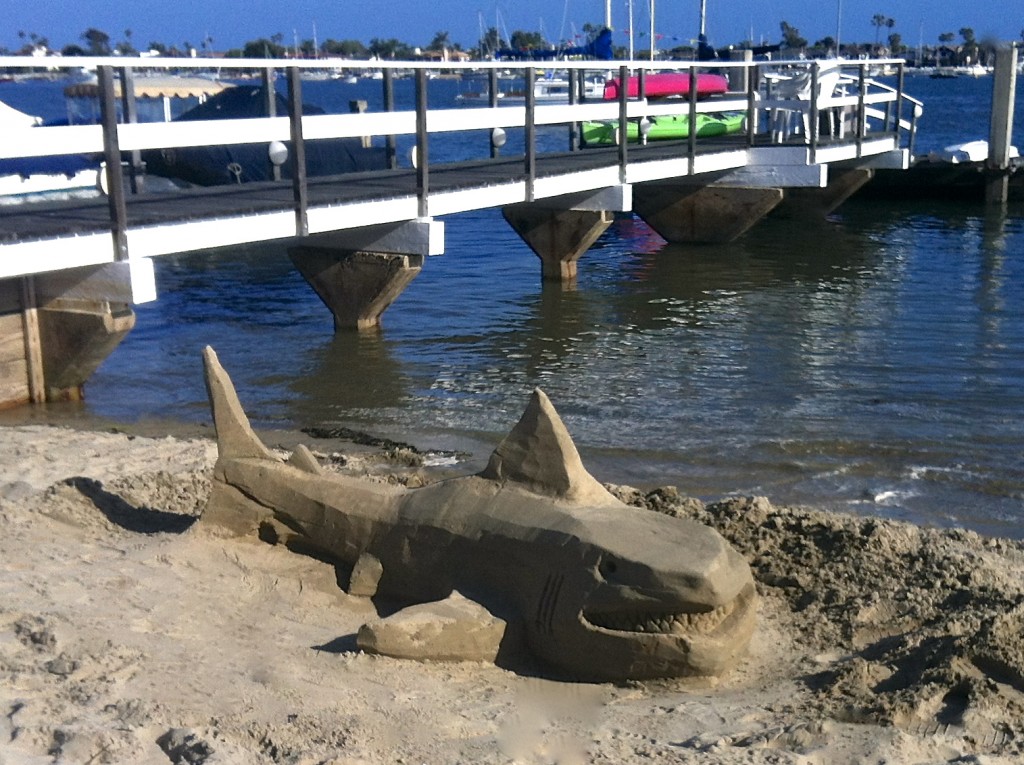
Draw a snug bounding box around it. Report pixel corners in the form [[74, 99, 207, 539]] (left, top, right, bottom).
[[8, 22, 1024, 66]]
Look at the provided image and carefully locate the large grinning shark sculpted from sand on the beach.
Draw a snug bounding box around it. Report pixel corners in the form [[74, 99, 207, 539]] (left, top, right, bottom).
[[203, 347, 756, 680]]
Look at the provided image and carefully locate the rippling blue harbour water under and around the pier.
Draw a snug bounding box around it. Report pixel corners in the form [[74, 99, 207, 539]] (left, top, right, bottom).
[[0, 71, 1024, 538]]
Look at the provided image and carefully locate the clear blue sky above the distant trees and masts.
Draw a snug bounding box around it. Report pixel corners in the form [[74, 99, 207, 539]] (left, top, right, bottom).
[[0, 0, 1024, 50]]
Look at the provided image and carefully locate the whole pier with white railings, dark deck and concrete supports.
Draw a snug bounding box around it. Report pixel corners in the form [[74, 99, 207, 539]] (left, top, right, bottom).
[[0, 57, 922, 406]]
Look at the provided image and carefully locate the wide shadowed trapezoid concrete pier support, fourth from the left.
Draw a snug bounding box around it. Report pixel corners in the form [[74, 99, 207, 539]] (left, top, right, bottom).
[[633, 183, 783, 244]]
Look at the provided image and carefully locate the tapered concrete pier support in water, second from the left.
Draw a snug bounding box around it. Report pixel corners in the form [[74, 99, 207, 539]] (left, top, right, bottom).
[[288, 247, 423, 331]]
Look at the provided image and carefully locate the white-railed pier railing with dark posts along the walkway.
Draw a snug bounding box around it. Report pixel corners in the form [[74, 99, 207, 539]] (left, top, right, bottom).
[[0, 56, 921, 260]]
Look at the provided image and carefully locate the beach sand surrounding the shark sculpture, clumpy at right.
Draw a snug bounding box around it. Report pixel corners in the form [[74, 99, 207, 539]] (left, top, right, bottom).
[[0, 425, 1024, 765]]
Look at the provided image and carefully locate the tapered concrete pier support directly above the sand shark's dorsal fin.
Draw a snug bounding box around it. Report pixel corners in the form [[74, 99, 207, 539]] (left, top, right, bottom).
[[502, 203, 613, 284]]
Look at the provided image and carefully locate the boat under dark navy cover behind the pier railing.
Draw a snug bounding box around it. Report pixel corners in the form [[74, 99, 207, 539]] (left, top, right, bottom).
[[142, 85, 387, 186]]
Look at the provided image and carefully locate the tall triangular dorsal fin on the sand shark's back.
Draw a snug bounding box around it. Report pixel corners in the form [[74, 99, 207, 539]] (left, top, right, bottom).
[[480, 388, 614, 504]]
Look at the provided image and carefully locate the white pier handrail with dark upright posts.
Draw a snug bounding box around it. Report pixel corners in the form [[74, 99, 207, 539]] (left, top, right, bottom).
[[0, 56, 921, 260]]
